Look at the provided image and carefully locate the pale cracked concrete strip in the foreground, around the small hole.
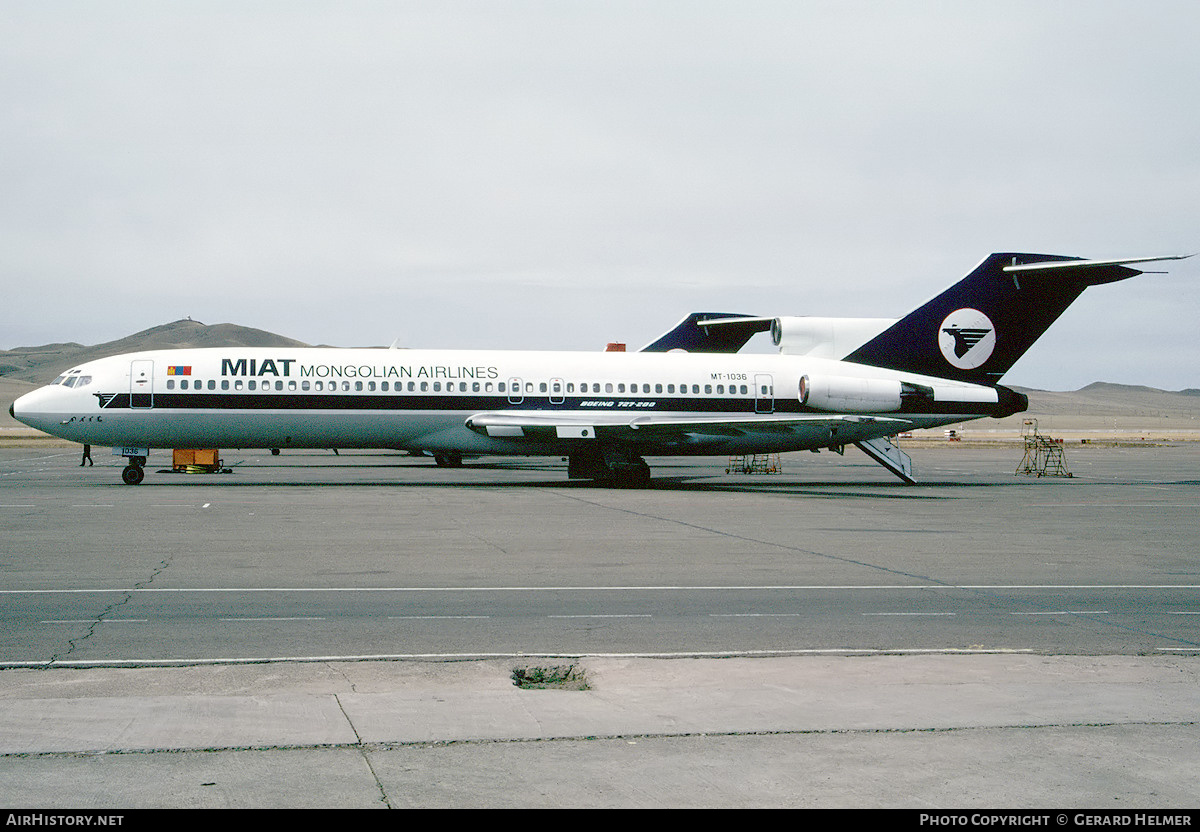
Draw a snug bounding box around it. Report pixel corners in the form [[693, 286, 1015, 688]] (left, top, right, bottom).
[[0, 656, 1200, 809]]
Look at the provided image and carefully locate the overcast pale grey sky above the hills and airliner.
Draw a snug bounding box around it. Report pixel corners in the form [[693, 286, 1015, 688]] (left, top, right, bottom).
[[0, 0, 1200, 389]]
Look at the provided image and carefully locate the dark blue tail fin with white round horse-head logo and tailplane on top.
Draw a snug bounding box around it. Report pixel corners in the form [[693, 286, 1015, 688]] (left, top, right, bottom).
[[845, 253, 1181, 384]]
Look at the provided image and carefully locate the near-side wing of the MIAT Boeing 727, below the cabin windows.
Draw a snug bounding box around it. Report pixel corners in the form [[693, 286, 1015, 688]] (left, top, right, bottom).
[[466, 411, 912, 441]]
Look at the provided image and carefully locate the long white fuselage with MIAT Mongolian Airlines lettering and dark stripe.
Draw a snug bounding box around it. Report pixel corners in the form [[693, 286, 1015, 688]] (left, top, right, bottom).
[[13, 348, 997, 455]]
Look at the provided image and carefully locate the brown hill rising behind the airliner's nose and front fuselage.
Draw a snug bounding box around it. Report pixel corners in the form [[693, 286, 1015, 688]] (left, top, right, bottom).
[[0, 318, 310, 384]]
